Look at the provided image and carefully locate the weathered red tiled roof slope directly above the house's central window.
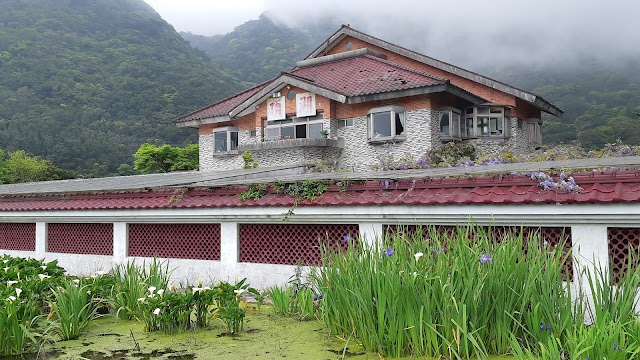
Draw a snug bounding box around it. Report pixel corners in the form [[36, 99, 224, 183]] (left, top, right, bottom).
[[289, 55, 447, 96]]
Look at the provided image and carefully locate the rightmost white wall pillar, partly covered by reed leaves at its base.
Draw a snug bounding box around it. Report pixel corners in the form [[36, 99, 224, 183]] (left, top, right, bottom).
[[571, 225, 609, 324]]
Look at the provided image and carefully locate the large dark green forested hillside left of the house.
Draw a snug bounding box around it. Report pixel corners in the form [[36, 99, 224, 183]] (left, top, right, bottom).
[[0, 0, 244, 175]]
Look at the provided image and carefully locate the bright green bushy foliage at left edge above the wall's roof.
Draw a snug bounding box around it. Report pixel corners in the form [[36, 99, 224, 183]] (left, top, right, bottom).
[[0, 149, 74, 184]]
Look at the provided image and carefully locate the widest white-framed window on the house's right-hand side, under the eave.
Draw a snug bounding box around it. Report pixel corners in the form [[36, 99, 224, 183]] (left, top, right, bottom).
[[464, 106, 507, 137]]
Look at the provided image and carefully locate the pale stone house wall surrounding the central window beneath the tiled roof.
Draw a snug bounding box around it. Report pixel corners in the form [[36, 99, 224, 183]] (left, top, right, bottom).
[[336, 109, 440, 171]]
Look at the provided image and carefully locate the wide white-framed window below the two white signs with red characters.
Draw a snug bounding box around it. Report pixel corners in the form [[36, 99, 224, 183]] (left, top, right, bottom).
[[265, 113, 324, 140]]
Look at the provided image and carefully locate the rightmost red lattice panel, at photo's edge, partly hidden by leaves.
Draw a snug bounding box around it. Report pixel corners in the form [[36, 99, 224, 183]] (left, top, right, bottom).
[[607, 227, 640, 283]]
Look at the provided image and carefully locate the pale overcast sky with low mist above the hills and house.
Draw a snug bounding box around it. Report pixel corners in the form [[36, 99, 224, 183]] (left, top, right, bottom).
[[145, 0, 640, 65]]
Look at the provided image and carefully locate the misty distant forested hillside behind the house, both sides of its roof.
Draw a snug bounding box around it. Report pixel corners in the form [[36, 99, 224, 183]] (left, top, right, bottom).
[[182, 15, 640, 148]]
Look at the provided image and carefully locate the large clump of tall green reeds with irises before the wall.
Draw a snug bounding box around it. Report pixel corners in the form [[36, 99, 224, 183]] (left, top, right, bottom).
[[316, 225, 580, 358]]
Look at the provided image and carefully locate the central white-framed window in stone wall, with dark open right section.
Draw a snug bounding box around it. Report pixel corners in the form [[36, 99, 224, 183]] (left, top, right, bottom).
[[367, 106, 405, 141]]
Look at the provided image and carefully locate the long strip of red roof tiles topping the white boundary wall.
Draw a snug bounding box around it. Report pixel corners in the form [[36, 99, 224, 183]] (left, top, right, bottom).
[[0, 171, 640, 212]]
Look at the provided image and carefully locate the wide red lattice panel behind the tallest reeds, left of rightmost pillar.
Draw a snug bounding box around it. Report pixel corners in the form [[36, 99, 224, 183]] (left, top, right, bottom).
[[383, 225, 573, 280]]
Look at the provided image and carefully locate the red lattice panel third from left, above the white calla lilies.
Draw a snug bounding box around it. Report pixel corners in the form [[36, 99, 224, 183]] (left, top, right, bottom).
[[129, 224, 220, 260]]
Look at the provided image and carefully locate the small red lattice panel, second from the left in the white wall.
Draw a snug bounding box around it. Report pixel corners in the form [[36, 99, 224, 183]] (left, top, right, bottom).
[[47, 224, 113, 255]]
